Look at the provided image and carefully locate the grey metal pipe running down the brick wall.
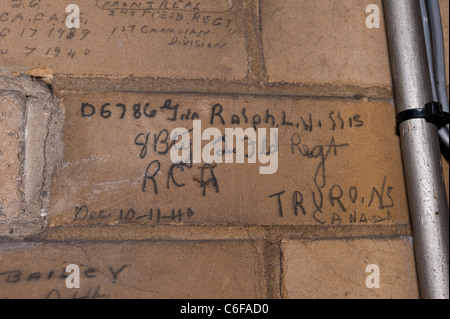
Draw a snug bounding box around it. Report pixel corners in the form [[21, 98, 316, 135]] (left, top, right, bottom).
[[384, 0, 449, 299]]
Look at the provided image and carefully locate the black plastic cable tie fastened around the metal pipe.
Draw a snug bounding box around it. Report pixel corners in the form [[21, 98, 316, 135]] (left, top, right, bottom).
[[396, 102, 450, 132]]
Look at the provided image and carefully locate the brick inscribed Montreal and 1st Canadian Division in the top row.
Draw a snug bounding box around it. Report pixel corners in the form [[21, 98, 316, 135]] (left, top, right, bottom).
[[0, 0, 248, 80]]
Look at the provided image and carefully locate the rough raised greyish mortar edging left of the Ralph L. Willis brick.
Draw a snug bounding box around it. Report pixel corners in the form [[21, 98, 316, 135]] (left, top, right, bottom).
[[0, 75, 65, 239]]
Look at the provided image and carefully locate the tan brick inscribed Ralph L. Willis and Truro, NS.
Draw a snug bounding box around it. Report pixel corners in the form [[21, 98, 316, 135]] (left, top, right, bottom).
[[49, 94, 409, 226]]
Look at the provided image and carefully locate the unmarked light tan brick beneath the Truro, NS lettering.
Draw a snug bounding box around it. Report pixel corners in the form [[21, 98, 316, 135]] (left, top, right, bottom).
[[282, 238, 419, 299]]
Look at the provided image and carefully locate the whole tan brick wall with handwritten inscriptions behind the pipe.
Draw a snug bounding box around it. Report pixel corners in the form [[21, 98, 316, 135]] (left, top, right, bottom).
[[0, 0, 449, 298]]
